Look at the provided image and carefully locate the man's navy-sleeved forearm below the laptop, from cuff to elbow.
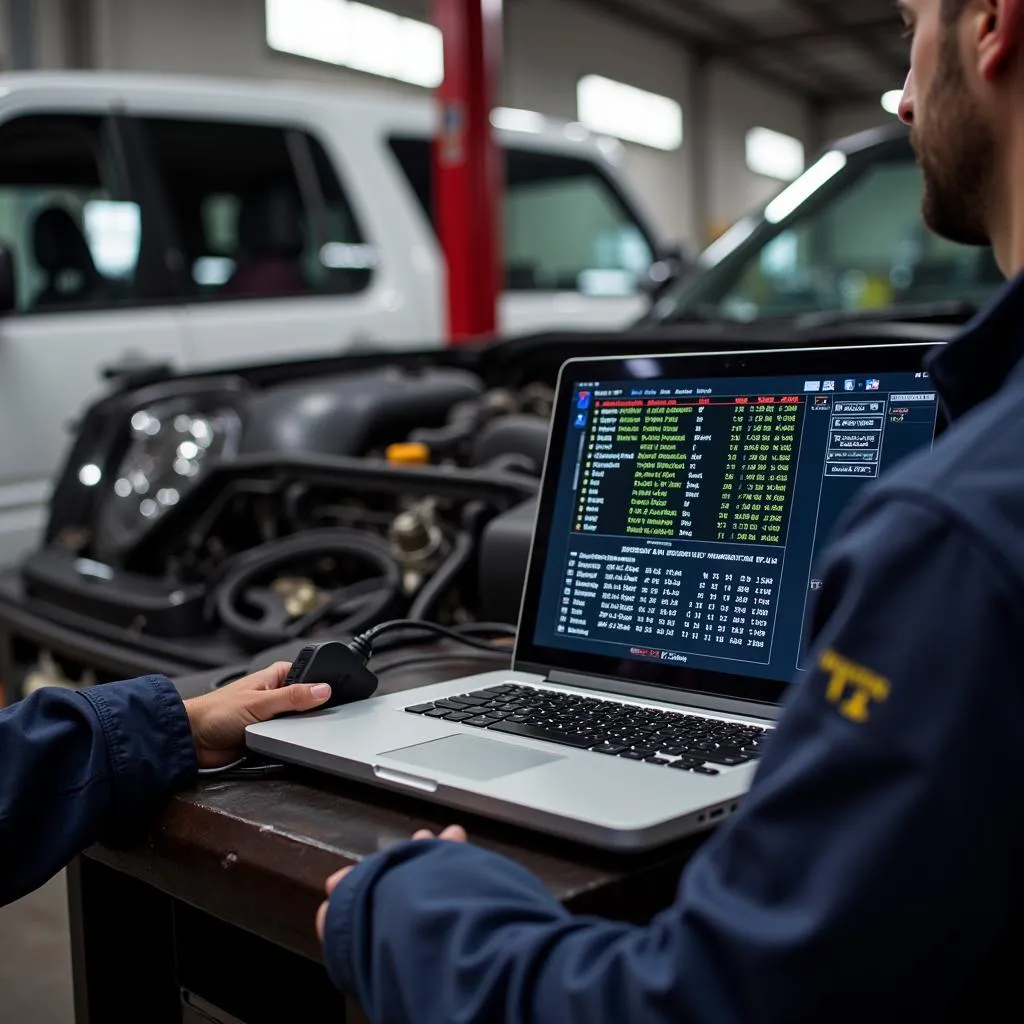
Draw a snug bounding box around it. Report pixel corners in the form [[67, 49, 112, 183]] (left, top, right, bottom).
[[325, 842, 741, 1024]]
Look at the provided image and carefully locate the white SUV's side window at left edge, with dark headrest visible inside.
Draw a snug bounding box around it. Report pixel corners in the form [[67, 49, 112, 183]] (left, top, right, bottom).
[[0, 115, 154, 312]]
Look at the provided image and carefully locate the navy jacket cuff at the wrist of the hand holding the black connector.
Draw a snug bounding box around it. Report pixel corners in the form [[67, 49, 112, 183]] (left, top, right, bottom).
[[80, 676, 199, 817]]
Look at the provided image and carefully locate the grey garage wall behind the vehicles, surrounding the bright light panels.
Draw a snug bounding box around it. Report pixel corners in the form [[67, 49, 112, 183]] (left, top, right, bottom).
[[0, 0, 808, 245]]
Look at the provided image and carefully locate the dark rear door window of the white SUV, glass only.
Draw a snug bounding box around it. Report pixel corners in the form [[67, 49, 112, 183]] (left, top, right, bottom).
[[143, 118, 376, 300]]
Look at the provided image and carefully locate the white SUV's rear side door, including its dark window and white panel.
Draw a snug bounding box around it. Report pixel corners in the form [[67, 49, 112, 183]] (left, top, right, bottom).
[[137, 112, 423, 367]]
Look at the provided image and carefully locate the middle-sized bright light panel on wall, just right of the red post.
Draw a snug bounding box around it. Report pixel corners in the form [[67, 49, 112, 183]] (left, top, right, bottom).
[[577, 75, 683, 151]]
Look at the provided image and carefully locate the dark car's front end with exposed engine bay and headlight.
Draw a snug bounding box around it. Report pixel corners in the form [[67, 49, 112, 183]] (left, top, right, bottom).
[[0, 325, 958, 682]]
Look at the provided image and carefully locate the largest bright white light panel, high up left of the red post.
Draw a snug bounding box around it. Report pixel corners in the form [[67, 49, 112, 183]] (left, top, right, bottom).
[[266, 0, 444, 89]]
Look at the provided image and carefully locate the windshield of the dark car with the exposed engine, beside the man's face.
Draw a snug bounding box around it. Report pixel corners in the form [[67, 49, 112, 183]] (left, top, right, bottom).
[[655, 134, 1001, 322]]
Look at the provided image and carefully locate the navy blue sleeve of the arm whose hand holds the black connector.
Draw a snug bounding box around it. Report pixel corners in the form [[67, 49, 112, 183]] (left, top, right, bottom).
[[0, 676, 197, 905]]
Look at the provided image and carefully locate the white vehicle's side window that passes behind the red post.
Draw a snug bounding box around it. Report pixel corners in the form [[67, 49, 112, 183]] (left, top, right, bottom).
[[390, 137, 653, 297]]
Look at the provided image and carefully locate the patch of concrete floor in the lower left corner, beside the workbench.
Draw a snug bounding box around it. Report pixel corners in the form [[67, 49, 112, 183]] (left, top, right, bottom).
[[0, 873, 75, 1024]]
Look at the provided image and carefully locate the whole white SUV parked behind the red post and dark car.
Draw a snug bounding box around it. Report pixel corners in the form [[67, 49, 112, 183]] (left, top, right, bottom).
[[0, 73, 671, 564]]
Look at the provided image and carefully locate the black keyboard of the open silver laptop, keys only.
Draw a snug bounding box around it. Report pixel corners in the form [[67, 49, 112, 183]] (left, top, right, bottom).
[[406, 683, 771, 775]]
